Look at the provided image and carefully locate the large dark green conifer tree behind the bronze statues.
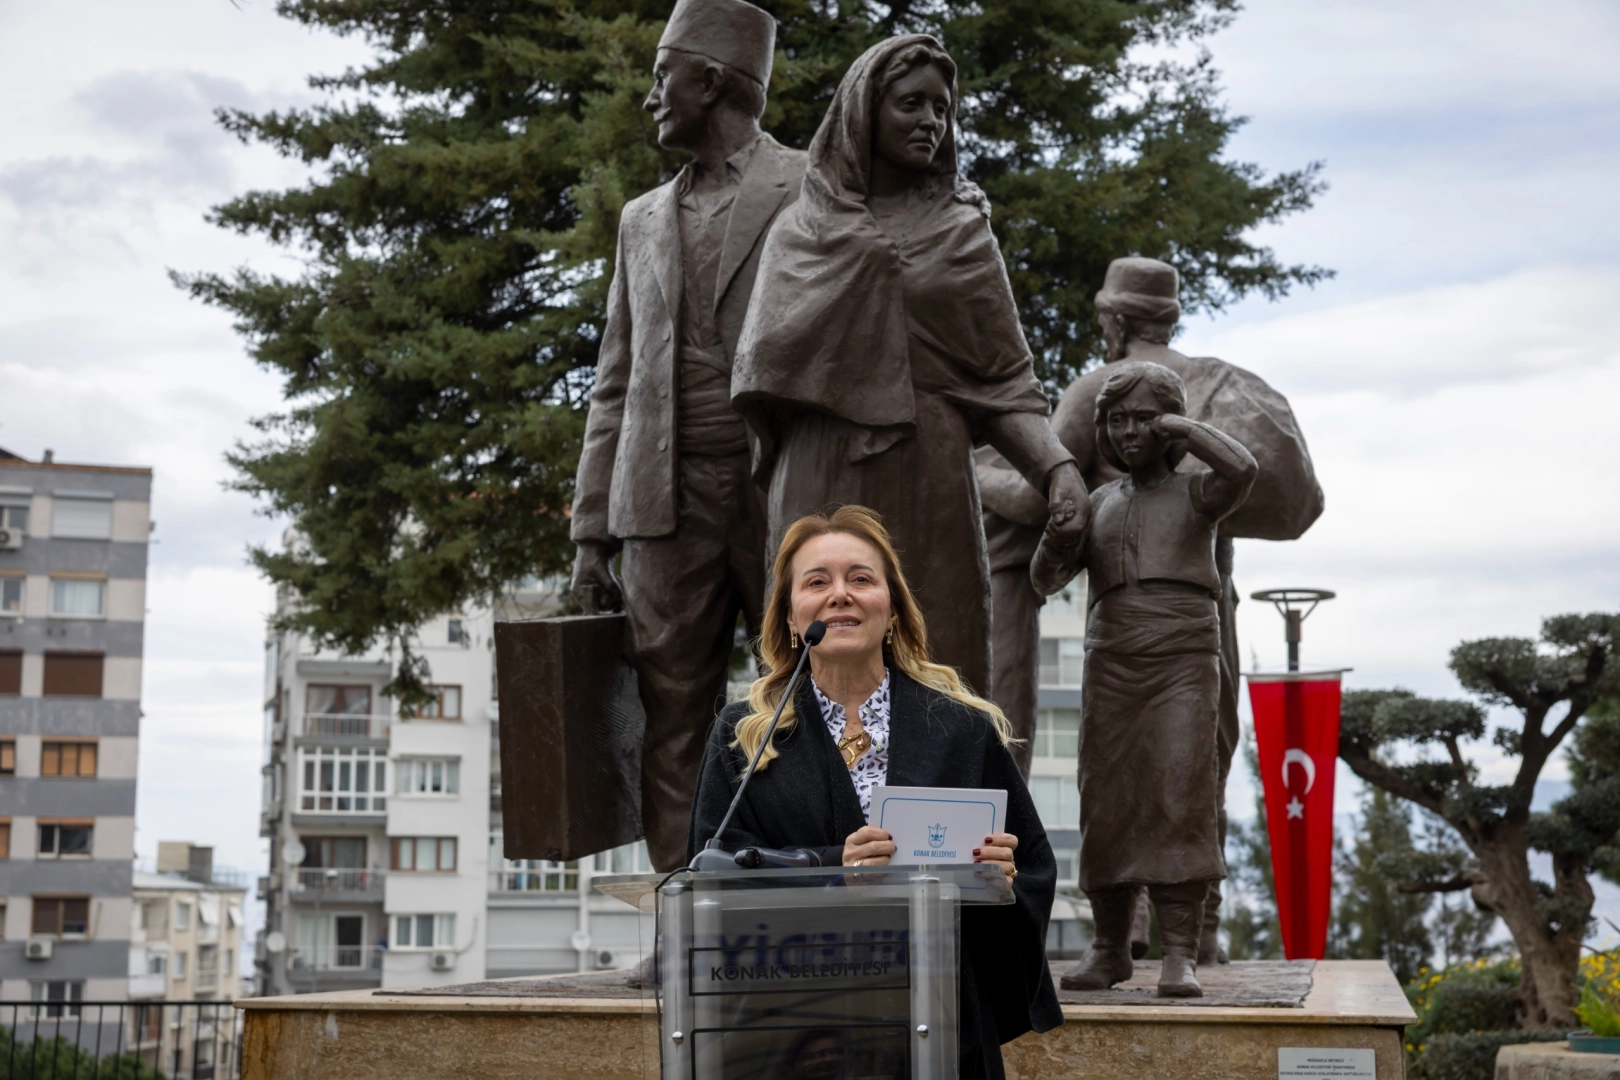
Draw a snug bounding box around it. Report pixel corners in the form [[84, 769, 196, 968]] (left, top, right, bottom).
[[177, 0, 1325, 690]]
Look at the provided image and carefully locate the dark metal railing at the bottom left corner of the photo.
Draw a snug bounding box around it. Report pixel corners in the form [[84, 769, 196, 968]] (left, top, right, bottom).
[[0, 1003, 241, 1080]]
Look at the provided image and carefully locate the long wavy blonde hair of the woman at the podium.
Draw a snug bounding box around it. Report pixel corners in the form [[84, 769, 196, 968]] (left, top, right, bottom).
[[731, 505, 1014, 769]]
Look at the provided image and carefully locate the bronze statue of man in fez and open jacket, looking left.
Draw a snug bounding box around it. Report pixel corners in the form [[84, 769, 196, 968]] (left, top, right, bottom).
[[572, 0, 805, 870]]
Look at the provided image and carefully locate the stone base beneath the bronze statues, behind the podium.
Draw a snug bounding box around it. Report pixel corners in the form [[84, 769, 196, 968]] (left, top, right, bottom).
[[237, 960, 1416, 1080]]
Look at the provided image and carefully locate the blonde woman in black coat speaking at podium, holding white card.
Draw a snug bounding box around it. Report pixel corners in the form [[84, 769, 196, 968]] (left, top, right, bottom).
[[689, 507, 1063, 1080]]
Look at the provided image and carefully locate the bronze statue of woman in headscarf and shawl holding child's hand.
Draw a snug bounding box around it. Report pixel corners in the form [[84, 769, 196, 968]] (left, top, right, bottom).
[[731, 34, 1090, 693]]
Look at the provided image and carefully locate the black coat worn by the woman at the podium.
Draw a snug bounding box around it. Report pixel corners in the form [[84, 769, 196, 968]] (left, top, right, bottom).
[[687, 669, 1063, 1078]]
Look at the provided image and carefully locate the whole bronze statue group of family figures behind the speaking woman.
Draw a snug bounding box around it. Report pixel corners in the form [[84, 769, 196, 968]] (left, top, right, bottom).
[[572, 0, 1322, 1062]]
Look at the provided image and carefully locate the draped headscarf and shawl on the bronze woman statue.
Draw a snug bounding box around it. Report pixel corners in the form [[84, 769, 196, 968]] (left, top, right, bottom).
[[731, 34, 1048, 479]]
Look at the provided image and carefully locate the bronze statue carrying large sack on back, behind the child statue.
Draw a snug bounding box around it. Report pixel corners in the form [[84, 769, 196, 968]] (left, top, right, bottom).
[[978, 257, 1322, 963]]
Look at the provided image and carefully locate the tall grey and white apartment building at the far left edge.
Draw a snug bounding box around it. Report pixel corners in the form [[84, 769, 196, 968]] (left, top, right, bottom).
[[0, 450, 152, 1015]]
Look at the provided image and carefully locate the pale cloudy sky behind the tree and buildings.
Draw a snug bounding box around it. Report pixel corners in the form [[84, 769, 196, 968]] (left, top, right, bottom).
[[0, 0, 1620, 932]]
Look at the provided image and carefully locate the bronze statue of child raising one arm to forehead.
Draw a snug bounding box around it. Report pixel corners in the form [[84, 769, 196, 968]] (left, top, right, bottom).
[[1030, 361, 1259, 997]]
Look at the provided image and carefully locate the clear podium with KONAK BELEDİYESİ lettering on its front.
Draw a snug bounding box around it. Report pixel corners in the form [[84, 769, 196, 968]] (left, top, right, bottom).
[[593, 865, 1013, 1080]]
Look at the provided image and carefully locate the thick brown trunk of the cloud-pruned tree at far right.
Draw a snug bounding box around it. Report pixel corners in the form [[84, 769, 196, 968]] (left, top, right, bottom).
[[1471, 826, 1581, 1028]]
